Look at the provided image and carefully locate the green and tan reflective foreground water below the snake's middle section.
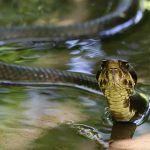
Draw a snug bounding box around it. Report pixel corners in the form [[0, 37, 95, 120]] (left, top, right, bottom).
[[0, 87, 105, 149]]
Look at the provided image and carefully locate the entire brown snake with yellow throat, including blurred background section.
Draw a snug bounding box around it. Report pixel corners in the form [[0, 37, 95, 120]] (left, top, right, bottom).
[[0, 0, 148, 121]]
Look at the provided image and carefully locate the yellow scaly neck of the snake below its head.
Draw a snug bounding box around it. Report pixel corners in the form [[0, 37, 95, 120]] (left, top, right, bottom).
[[104, 86, 136, 121]]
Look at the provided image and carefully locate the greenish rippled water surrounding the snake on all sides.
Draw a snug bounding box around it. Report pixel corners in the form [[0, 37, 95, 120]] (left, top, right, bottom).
[[0, 0, 150, 150]]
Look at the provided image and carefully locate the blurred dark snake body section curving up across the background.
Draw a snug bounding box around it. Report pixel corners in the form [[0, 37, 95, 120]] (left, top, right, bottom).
[[0, 0, 143, 42]]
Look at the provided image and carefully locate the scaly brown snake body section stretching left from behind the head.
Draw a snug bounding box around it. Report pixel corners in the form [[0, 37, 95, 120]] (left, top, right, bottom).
[[0, 62, 99, 91]]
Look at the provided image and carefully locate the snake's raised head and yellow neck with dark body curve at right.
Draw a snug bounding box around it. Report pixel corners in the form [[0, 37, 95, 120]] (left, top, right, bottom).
[[96, 59, 149, 122]]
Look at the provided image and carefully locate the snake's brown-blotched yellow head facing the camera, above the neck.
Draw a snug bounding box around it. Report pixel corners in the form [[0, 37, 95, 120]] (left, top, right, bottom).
[[96, 59, 137, 93]]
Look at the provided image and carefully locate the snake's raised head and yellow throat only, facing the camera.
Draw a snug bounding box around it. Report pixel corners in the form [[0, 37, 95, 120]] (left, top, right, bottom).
[[97, 60, 136, 121]]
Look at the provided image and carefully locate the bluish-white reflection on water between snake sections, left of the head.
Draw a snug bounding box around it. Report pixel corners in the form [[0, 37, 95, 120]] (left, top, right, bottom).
[[67, 39, 105, 74]]
